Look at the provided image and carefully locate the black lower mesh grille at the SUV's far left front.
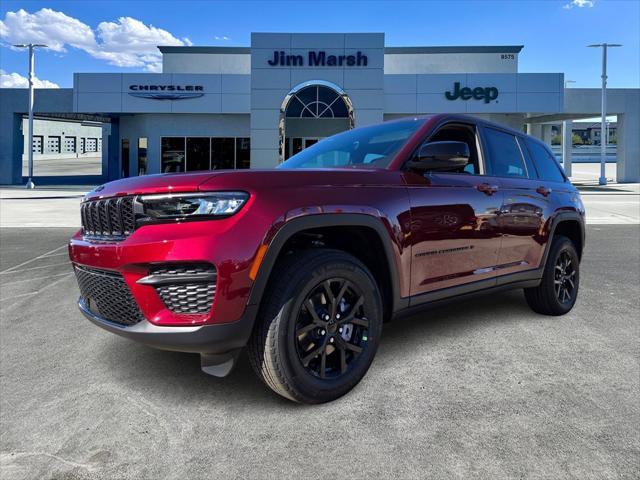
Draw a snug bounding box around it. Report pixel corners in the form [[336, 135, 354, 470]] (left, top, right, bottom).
[[75, 265, 144, 325]]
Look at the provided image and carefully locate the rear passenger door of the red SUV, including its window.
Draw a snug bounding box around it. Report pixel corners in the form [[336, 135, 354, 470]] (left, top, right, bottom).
[[481, 126, 551, 276]]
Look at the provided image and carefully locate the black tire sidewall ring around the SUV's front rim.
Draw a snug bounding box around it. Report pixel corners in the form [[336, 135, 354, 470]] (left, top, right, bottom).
[[277, 255, 382, 403]]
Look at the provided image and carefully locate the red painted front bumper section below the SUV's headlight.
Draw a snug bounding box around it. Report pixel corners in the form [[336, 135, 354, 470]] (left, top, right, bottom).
[[69, 206, 262, 326]]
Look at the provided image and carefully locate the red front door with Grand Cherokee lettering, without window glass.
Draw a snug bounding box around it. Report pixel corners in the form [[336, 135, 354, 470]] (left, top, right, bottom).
[[404, 124, 502, 296]]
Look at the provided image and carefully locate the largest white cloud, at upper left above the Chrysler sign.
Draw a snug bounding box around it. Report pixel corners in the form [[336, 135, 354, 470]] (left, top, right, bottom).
[[0, 8, 192, 72]]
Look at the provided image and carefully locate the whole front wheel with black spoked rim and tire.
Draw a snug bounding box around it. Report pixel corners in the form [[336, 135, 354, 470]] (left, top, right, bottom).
[[248, 249, 382, 404]]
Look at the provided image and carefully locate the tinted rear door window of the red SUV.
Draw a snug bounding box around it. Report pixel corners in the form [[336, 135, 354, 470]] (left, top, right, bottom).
[[484, 128, 527, 178]]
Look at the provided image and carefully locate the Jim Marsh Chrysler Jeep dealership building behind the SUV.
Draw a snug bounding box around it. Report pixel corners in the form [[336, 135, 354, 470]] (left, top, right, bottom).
[[0, 33, 640, 184]]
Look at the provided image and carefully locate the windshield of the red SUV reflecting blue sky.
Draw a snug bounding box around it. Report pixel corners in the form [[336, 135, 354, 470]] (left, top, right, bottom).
[[278, 118, 424, 169]]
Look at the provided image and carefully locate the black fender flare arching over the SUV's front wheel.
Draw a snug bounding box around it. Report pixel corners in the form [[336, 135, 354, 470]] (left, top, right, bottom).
[[247, 213, 408, 314]]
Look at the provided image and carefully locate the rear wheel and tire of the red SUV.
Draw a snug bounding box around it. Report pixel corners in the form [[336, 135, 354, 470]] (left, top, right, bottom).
[[524, 235, 580, 315]]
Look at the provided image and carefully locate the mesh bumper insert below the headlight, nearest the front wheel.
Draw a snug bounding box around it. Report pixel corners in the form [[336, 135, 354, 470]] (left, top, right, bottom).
[[150, 264, 216, 314]]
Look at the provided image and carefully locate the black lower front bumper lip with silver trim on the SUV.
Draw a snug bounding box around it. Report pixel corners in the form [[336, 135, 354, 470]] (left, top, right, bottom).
[[78, 299, 257, 354]]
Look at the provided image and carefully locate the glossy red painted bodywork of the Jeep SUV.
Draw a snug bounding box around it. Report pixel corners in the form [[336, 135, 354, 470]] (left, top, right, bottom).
[[69, 115, 582, 325]]
